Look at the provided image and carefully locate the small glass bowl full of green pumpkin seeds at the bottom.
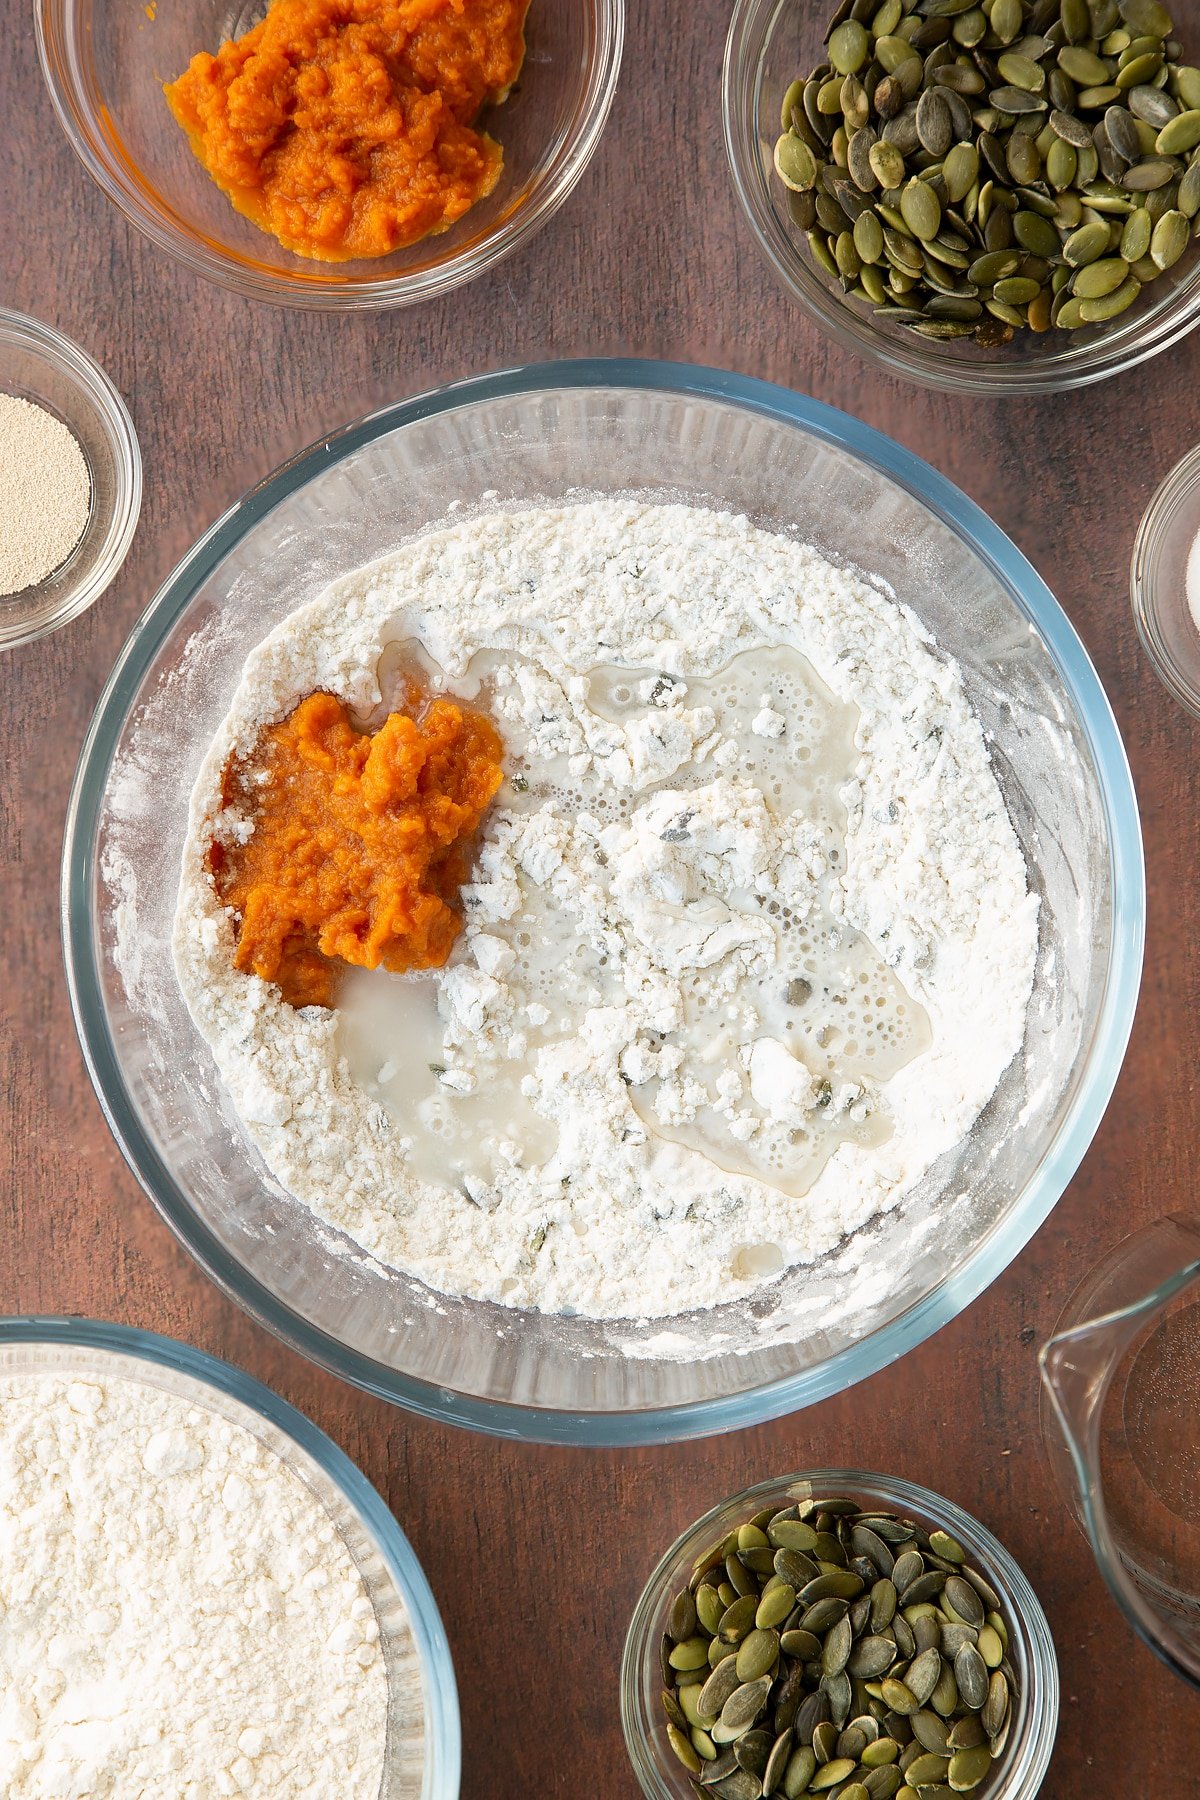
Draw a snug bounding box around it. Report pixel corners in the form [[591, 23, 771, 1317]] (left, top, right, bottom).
[[621, 1469, 1058, 1800]]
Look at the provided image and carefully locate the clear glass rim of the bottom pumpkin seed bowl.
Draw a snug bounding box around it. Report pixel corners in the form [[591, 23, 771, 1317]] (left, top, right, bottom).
[[621, 1469, 1060, 1800]]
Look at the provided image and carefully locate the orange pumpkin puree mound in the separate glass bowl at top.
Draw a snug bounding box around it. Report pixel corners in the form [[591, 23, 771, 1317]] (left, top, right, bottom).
[[164, 0, 529, 263]]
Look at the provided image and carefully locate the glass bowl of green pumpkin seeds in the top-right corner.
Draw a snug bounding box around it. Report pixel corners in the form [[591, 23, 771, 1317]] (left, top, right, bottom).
[[723, 0, 1200, 392]]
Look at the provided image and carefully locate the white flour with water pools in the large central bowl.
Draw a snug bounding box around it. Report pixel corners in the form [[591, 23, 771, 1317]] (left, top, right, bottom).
[[175, 500, 1036, 1318]]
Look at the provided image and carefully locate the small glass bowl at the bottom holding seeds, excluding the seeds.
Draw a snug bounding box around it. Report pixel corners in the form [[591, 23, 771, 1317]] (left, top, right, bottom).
[[621, 1469, 1058, 1800]]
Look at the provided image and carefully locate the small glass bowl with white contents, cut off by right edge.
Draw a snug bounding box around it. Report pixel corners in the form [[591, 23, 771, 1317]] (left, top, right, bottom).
[[1130, 445, 1200, 718]]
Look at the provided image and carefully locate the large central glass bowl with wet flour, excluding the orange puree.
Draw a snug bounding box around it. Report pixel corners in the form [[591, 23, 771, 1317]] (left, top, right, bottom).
[[65, 364, 1144, 1442]]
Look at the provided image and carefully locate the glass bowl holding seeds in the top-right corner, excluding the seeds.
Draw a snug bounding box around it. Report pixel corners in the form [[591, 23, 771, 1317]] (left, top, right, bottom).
[[721, 0, 1200, 394]]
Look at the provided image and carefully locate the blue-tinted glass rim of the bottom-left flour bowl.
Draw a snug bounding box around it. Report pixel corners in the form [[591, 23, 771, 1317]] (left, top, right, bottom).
[[0, 1314, 462, 1800]]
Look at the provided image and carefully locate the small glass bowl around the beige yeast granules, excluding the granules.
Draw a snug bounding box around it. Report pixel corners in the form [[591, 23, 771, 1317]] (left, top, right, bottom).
[[0, 308, 142, 650]]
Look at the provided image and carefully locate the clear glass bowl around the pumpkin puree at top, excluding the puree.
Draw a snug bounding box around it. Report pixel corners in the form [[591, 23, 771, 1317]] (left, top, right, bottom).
[[36, 0, 624, 311]]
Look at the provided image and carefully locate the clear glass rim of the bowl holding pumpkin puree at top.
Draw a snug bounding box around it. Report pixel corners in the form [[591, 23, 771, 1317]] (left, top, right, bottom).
[[34, 0, 624, 311]]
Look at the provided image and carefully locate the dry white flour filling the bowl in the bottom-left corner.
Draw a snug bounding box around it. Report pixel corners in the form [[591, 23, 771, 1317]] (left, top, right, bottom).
[[0, 1375, 389, 1800]]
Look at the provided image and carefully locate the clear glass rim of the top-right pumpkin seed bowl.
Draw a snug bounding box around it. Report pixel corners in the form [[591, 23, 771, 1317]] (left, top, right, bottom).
[[721, 0, 1200, 396]]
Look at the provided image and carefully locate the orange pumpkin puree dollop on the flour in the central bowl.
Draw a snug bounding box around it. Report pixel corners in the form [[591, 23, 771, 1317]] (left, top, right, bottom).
[[209, 691, 504, 1006]]
